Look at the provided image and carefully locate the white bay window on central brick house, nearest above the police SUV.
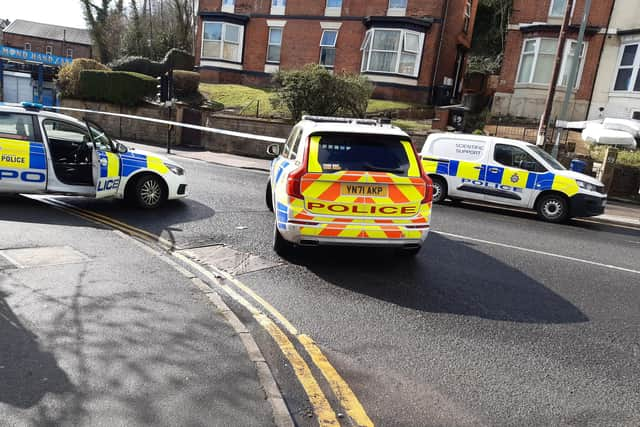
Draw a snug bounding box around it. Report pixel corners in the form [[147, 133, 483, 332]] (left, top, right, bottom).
[[360, 28, 424, 77]]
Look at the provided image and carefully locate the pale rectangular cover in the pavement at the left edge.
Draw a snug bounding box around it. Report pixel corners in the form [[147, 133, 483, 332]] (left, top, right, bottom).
[[0, 246, 89, 268]]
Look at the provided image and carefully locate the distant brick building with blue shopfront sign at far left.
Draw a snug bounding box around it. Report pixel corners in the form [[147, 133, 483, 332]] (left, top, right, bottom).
[[0, 19, 92, 105]]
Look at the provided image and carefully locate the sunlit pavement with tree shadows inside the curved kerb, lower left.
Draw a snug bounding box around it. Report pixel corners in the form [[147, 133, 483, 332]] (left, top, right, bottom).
[[0, 197, 274, 426]]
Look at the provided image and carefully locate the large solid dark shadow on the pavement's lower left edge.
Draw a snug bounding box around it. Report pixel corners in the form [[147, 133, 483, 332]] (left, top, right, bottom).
[[0, 290, 74, 409]]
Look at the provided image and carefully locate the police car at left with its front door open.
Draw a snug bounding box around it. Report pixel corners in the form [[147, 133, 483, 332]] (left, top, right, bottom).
[[0, 103, 187, 208]]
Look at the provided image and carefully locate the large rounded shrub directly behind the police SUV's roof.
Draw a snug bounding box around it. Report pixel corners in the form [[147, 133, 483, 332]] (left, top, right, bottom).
[[274, 64, 373, 121]]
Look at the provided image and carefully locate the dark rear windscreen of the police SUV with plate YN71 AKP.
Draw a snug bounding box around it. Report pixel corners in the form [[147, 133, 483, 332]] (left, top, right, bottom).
[[314, 133, 410, 176]]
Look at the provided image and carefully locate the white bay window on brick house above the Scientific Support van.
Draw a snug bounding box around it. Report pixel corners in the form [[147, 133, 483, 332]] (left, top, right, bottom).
[[517, 38, 586, 89]]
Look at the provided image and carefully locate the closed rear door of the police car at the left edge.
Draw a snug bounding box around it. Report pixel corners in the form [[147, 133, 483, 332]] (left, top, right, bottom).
[[0, 112, 47, 193]]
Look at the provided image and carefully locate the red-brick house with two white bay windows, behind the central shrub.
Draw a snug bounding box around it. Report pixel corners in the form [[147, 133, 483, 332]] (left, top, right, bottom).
[[196, 0, 478, 103]]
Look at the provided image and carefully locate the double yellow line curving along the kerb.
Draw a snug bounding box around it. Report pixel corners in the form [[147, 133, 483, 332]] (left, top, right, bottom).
[[33, 196, 373, 427]]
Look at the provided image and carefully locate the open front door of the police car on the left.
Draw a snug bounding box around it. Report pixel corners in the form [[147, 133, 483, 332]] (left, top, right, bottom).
[[87, 122, 121, 199]]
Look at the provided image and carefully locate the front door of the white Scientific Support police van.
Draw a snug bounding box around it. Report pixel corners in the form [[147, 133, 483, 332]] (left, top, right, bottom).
[[486, 142, 546, 208]]
